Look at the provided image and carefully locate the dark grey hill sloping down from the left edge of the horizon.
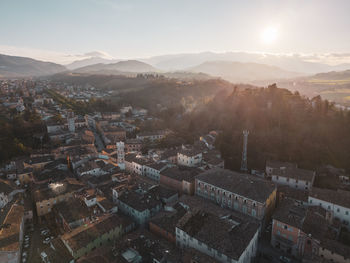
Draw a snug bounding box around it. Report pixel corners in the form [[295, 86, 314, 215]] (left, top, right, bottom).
[[0, 54, 67, 78]]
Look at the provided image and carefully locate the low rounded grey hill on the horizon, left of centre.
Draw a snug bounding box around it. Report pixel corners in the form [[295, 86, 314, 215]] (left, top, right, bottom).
[[74, 60, 157, 75]]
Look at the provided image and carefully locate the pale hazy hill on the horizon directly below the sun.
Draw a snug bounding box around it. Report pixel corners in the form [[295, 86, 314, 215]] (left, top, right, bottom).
[[190, 61, 301, 82]]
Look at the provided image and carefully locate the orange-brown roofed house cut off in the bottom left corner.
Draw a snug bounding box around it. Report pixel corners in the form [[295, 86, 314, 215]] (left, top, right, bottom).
[[0, 203, 24, 263]]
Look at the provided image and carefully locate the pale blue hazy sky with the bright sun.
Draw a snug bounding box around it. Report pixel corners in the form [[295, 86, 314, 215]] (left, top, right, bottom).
[[0, 0, 350, 63]]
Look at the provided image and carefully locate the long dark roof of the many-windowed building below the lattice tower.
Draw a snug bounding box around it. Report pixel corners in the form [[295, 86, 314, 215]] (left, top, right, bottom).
[[196, 168, 276, 203]]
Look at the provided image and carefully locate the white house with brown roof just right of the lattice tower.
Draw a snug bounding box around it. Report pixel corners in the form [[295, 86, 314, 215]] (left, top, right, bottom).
[[271, 168, 315, 190]]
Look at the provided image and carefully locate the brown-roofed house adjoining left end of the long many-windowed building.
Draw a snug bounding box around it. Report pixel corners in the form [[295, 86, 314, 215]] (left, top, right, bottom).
[[159, 166, 203, 195]]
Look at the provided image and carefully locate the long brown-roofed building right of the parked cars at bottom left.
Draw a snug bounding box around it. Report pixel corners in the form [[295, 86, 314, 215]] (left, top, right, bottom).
[[61, 214, 135, 259]]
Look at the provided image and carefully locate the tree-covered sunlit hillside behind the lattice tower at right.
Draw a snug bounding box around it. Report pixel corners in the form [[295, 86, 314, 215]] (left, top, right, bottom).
[[182, 85, 350, 170]]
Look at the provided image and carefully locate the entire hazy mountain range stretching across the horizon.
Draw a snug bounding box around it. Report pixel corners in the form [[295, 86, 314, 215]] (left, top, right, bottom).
[[0, 52, 350, 82]]
